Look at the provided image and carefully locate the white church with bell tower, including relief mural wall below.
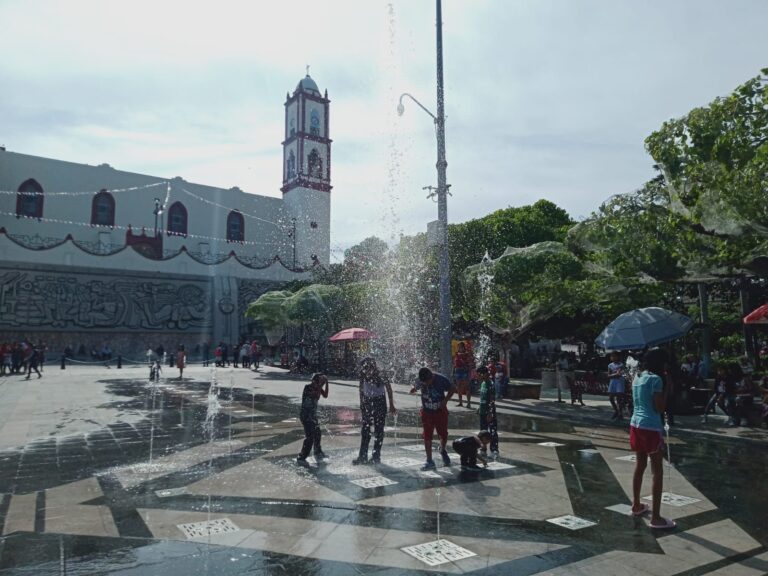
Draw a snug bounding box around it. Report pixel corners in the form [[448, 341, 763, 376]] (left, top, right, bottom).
[[0, 75, 331, 356]]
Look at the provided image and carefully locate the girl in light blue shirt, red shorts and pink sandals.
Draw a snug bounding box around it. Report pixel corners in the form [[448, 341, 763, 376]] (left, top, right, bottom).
[[629, 349, 675, 529]]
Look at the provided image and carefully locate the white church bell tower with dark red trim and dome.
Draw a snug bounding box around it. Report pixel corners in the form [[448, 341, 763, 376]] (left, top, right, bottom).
[[281, 70, 331, 268]]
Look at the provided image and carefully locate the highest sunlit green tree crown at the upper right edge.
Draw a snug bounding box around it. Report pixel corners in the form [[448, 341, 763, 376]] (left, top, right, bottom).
[[645, 69, 768, 274]]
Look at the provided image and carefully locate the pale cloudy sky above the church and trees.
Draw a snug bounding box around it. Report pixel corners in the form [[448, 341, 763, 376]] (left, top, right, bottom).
[[0, 0, 768, 261]]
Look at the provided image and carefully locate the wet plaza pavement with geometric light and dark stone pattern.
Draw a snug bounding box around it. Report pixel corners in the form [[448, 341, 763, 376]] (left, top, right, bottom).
[[0, 367, 768, 576]]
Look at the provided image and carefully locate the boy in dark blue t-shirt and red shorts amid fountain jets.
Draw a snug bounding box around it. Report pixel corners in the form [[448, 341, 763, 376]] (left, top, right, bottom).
[[410, 368, 456, 470]]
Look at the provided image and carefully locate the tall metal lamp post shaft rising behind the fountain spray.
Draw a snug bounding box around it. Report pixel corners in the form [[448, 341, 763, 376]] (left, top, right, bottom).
[[436, 0, 452, 375]]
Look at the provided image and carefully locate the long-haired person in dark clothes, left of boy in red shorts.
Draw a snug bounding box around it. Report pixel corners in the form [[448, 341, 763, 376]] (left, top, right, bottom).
[[352, 358, 397, 464]]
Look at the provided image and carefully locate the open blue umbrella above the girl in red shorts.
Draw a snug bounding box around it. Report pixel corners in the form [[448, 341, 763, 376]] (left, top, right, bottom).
[[595, 307, 693, 350]]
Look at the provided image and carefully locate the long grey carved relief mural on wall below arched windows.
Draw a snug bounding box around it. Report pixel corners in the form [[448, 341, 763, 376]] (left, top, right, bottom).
[[0, 270, 212, 331]]
